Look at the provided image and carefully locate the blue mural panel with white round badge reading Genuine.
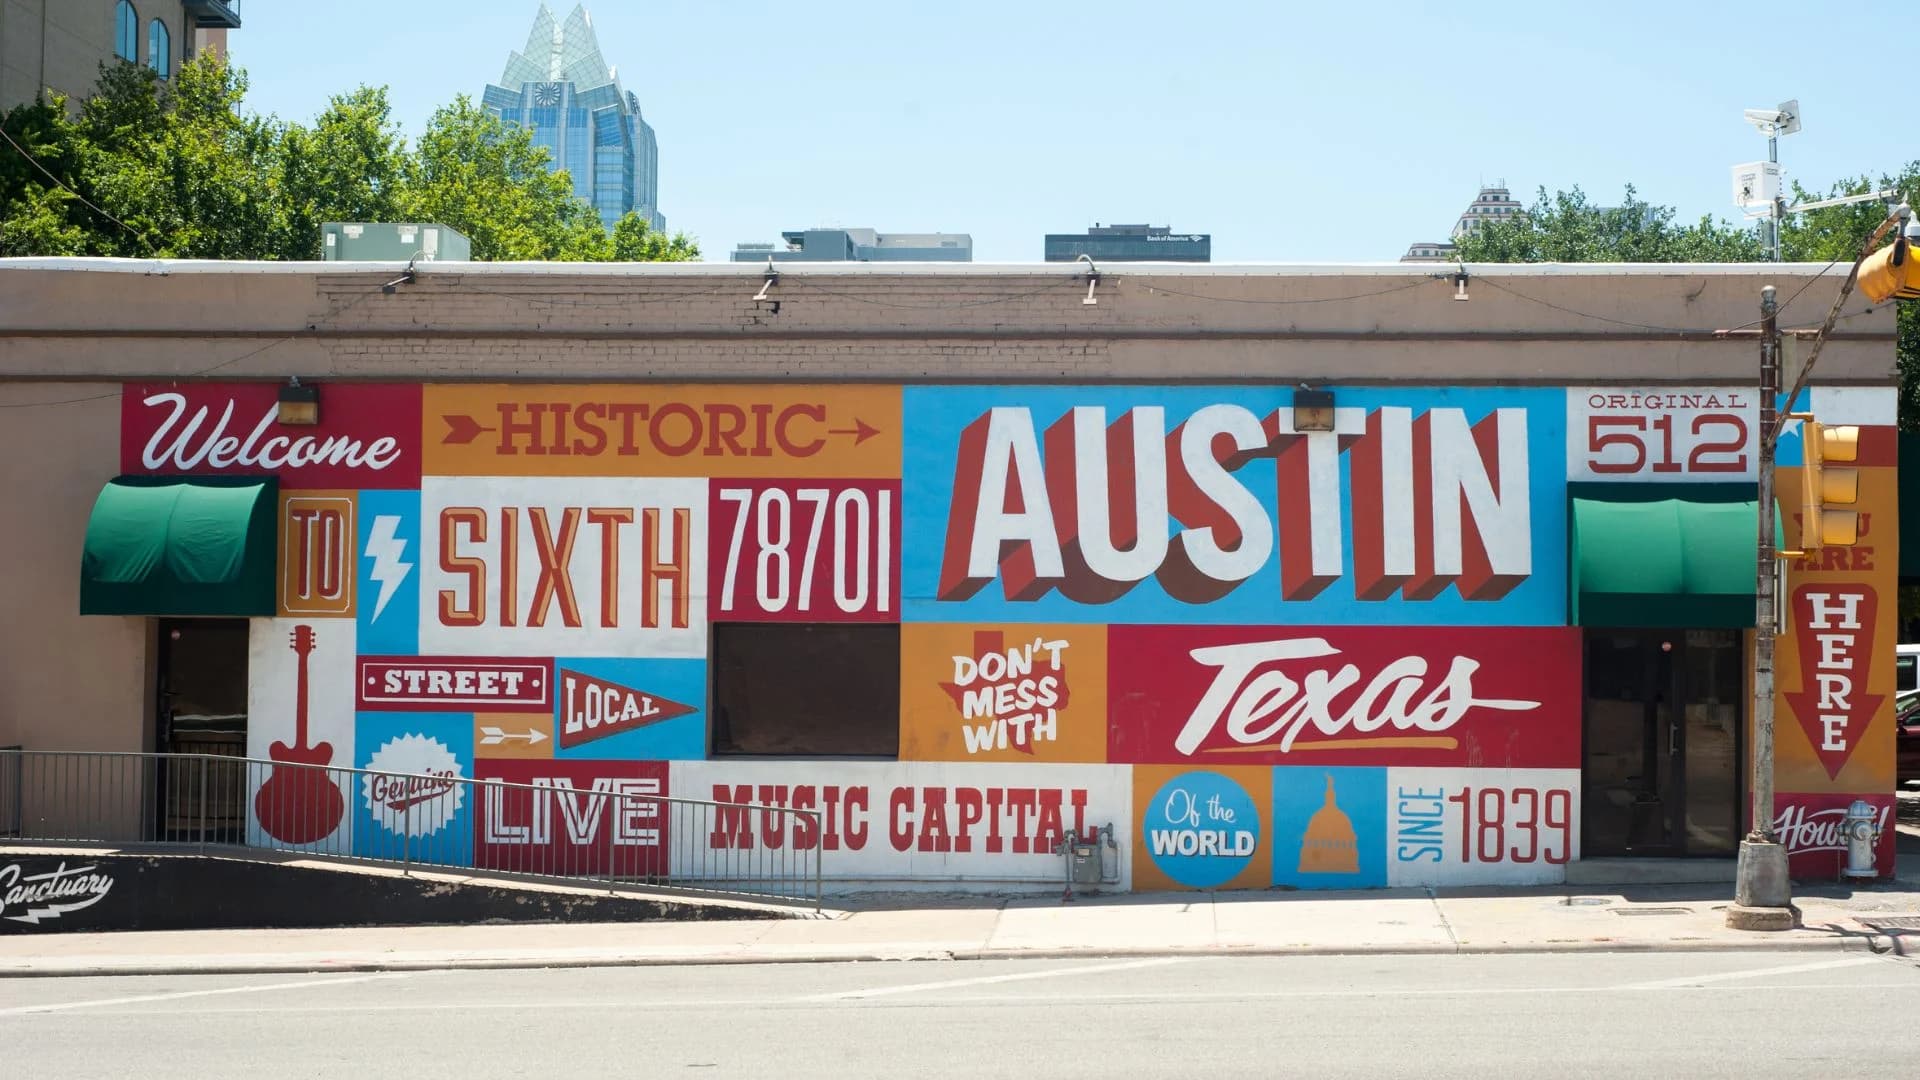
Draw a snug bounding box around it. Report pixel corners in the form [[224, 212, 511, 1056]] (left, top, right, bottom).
[[348, 713, 476, 867]]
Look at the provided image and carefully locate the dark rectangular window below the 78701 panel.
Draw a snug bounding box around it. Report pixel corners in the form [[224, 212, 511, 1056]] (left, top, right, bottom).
[[712, 623, 900, 757]]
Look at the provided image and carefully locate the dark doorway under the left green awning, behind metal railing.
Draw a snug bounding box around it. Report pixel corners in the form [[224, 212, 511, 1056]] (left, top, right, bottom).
[[154, 619, 248, 840]]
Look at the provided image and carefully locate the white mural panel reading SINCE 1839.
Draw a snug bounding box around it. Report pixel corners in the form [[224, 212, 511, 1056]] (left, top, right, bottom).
[[1386, 769, 1580, 886]]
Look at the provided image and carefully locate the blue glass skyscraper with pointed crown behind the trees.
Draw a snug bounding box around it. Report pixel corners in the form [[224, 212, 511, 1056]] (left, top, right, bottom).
[[480, 2, 666, 233]]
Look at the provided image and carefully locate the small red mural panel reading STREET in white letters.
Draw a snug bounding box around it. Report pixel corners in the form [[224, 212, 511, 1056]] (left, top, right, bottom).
[[353, 655, 553, 713]]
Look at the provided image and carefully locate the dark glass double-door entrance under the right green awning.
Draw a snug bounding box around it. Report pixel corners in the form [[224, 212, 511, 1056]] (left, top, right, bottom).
[[1580, 630, 1745, 855]]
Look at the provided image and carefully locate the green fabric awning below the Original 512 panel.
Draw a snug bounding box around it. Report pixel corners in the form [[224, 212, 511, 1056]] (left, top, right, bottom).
[[1567, 484, 1788, 630]]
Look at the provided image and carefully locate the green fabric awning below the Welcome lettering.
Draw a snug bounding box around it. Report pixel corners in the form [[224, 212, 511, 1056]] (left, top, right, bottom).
[[81, 477, 280, 615]]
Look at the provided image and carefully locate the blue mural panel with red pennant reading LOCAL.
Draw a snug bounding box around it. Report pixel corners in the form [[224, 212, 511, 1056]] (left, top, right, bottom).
[[553, 657, 707, 761]]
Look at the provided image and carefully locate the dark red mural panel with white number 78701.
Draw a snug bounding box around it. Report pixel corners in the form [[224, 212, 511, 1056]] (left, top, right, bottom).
[[707, 480, 900, 623]]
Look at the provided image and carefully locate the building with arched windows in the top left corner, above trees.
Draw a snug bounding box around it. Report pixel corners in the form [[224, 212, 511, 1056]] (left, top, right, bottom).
[[0, 0, 240, 110]]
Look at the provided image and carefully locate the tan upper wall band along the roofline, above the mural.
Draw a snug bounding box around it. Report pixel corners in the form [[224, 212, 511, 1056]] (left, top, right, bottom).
[[0, 259, 1893, 384]]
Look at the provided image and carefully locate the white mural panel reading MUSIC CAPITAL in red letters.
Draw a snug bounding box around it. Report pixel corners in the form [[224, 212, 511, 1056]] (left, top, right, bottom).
[[670, 761, 1133, 890]]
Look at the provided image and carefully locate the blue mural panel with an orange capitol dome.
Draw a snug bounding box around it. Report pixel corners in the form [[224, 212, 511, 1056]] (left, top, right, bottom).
[[1273, 767, 1386, 888]]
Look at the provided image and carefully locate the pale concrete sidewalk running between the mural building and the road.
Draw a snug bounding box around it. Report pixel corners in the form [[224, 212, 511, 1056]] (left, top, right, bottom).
[[0, 880, 1920, 976]]
